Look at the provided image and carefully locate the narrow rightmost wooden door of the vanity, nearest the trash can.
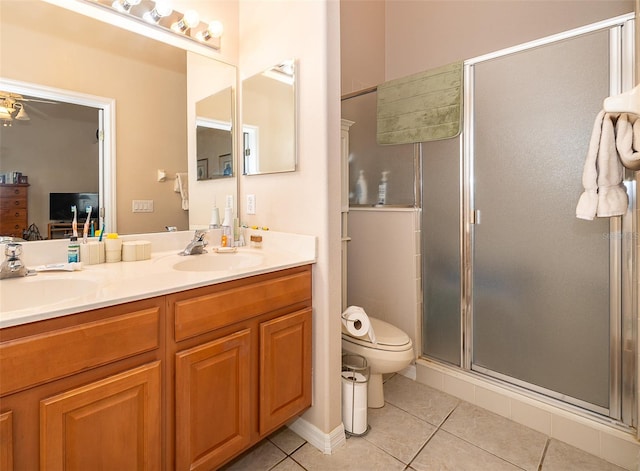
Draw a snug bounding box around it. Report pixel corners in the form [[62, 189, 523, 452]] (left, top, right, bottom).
[[260, 309, 311, 435]]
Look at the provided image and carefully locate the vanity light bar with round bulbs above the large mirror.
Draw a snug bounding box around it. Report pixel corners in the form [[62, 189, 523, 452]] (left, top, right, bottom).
[[89, 0, 223, 50]]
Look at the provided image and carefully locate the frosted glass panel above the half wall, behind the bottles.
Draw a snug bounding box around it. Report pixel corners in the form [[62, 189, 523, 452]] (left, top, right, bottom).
[[342, 92, 415, 206]]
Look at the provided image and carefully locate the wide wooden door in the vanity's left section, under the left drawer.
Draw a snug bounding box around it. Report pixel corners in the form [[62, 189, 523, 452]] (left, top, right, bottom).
[[40, 361, 162, 471]]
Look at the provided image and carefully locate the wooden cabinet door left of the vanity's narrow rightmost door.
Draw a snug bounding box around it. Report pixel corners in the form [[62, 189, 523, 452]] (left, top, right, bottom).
[[176, 329, 251, 470]]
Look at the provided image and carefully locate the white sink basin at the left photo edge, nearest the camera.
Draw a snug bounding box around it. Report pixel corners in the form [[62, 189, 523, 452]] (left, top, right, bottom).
[[0, 274, 98, 312]]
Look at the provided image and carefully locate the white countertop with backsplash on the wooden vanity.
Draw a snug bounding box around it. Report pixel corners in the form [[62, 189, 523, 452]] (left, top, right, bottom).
[[0, 231, 316, 328]]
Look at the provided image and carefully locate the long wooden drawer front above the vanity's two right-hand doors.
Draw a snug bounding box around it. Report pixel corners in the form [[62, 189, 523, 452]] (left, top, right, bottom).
[[170, 269, 311, 341]]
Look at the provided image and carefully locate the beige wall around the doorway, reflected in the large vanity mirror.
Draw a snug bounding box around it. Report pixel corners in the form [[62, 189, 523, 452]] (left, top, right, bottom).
[[0, 0, 188, 233]]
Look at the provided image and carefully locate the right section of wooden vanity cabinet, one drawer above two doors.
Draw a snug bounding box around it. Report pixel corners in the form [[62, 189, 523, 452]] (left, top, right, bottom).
[[167, 266, 311, 470]]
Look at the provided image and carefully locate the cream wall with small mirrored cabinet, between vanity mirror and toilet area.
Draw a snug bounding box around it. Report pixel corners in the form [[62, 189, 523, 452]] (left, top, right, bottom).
[[240, 0, 344, 438]]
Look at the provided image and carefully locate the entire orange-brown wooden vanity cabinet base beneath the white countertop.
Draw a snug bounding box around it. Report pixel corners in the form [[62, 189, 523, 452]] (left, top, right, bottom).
[[0, 232, 312, 470]]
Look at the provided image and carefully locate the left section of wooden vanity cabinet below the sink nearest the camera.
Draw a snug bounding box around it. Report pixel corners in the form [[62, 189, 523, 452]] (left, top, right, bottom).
[[0, 298, 165, 471]]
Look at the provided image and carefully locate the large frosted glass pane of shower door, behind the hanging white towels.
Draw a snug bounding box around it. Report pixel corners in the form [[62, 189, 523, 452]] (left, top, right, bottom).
[[472, 32, 609, 408]]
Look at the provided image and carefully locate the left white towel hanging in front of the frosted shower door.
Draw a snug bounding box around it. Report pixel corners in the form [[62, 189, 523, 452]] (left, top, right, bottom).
[[576, 111, 629, 220]]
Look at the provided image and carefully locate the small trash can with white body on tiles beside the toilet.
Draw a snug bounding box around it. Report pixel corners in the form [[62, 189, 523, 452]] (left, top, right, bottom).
[[342, 354, 370, 436]]
